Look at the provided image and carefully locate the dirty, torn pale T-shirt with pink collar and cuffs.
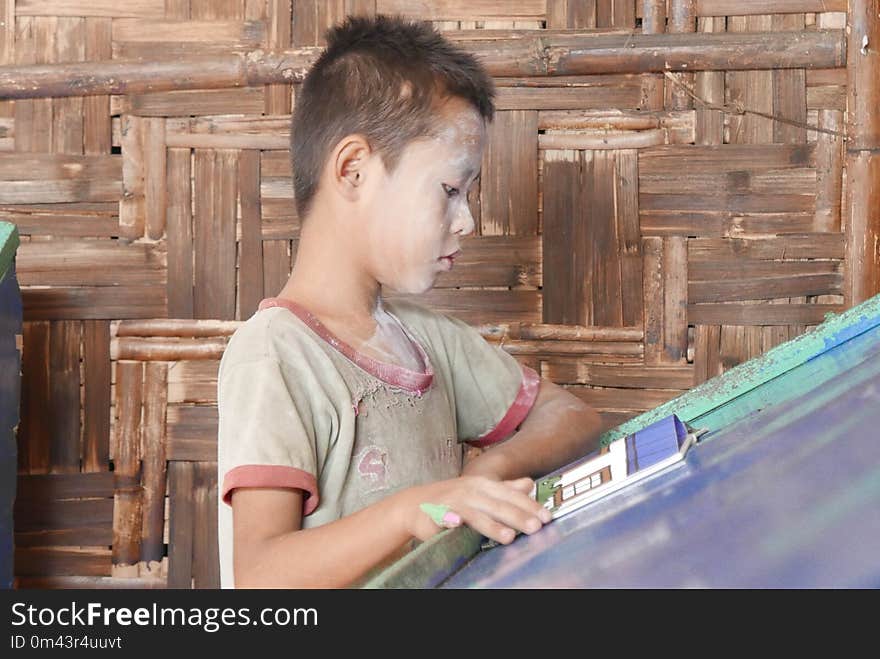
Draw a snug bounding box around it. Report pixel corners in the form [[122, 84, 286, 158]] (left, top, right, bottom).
[[217, 298, 540, 588]]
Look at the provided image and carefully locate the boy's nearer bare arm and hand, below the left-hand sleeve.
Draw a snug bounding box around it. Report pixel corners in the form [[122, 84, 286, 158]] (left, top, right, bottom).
[[232, 476, 550, 588]]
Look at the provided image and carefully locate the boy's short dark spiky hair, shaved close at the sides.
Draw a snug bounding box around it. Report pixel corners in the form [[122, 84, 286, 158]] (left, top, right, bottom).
[[290, 14, 495, 219]]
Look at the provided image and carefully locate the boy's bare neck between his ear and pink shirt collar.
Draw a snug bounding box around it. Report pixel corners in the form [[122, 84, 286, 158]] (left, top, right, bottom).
[[278, 209, 381, 320]]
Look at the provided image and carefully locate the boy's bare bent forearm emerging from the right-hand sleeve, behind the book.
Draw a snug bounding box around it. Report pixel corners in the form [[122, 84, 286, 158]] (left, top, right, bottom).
[[462, 378, 602, 480]]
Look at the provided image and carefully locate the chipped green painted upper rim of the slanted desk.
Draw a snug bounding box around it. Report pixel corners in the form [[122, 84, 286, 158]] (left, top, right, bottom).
[[600, 295, 880, 445]]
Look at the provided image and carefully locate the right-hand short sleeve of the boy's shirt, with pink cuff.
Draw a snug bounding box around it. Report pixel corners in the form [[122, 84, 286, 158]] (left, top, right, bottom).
[[441, 316, 541, 447]]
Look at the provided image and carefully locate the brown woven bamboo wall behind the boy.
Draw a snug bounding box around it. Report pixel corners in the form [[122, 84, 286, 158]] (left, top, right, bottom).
[[0, 0, 880, 587]]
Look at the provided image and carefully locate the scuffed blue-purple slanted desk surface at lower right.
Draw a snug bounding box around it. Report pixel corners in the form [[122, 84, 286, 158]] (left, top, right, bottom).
[[443, 327, 880, 588]]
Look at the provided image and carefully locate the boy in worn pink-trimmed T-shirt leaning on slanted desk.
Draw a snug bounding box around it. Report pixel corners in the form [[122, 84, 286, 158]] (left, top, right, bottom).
[[218, 15, 600, 587]]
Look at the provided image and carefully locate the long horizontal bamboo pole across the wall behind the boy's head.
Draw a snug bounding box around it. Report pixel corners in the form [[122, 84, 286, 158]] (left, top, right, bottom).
[[0, 30, 846, 98]]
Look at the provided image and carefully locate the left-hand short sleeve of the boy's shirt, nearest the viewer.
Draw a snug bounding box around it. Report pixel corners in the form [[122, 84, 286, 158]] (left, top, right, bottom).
[[217, 358, 319, 515]]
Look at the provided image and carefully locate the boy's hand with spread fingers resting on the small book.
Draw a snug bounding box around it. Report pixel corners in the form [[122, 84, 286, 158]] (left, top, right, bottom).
[[407, 476, 551, 545]]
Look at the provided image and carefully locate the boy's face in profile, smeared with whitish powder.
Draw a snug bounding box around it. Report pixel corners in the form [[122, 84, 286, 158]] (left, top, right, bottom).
[[364, 98, 486, 293]]
